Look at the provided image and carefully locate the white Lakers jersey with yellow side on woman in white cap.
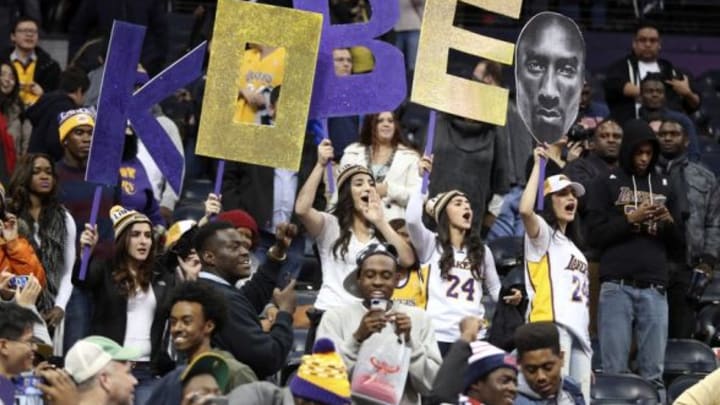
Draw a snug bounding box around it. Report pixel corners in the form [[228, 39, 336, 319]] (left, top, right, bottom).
[[525, 215, 592, 353]]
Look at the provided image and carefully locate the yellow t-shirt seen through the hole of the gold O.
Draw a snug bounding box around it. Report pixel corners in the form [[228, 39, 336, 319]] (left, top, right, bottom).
[[233, 47, 285, 124]]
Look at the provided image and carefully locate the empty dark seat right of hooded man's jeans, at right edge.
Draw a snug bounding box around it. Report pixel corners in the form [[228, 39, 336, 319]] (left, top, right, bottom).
[[663, 339, 717, 385]]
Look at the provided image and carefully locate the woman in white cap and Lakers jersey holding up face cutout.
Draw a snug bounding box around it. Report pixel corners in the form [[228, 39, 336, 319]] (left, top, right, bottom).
[[519, 146, 592, 401]]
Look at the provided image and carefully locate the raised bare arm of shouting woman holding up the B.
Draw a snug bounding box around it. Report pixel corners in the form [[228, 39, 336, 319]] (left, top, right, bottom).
[[295, 139, 333, 238]]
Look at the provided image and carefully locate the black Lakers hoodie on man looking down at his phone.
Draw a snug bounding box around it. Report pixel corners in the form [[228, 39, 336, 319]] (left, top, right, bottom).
[[587, 120, 682, 285]]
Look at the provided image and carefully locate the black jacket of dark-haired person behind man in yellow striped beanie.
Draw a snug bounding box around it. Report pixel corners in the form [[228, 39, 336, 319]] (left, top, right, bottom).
[[26, 90, 78, 161]]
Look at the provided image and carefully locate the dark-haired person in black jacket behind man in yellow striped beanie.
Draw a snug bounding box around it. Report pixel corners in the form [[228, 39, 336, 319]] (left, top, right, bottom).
[[26, 67, 89, 161]]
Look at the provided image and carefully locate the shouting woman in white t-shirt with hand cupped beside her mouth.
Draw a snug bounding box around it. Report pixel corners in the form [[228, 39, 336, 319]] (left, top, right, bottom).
[[295, 139, 415, 340]]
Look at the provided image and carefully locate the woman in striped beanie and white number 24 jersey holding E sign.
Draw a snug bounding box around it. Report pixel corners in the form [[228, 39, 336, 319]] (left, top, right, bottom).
[[405, 156, 522, 355]]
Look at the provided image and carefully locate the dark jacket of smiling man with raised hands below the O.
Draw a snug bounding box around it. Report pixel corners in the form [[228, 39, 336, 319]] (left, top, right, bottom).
[[199, 257, 294, 380]]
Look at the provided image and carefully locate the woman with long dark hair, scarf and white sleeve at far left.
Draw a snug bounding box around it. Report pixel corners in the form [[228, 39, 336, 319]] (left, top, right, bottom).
[[8, 154, 76, 327]]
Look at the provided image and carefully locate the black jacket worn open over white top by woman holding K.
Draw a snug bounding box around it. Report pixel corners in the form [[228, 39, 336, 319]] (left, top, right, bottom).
[[76, 260, 176, 375]]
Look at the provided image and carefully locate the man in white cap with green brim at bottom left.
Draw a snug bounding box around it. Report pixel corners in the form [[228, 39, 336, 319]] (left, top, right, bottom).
[[65, 336, 142, 405]]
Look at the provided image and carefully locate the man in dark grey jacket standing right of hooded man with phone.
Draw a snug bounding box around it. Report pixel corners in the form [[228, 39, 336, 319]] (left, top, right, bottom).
[[656, 120, 720, 339]]
